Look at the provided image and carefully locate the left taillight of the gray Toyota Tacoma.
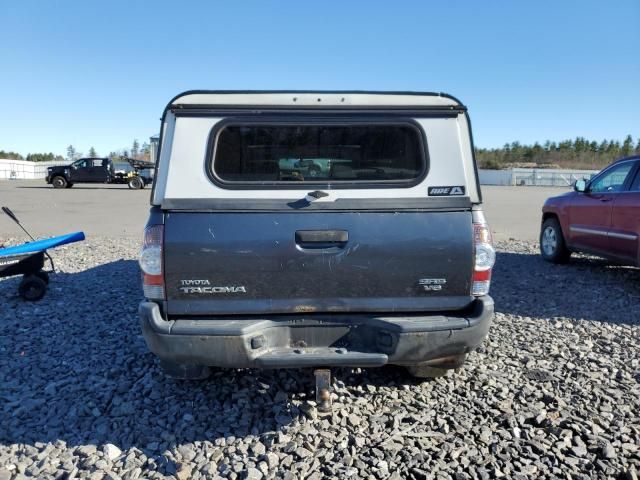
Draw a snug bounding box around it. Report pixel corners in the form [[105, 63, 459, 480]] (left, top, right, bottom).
[[138, 225, 164, 300]]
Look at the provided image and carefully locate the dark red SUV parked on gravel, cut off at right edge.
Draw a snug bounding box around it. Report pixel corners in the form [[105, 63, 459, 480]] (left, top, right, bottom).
[[540, 156, 640, 266]]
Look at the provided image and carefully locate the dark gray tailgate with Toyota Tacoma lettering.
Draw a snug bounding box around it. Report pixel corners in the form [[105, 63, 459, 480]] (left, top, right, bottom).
[[164, 210, 473, 316]]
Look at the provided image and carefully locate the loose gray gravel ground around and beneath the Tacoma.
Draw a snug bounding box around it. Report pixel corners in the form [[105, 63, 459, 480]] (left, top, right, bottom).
[[0, 238, 640, 480]]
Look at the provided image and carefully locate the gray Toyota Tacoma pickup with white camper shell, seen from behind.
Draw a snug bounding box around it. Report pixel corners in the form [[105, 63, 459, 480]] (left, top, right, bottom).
[[139, 91, 495, 378]]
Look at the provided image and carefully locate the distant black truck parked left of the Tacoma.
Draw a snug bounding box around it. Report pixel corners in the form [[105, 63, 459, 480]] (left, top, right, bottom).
[[46, 157, 155, 190]]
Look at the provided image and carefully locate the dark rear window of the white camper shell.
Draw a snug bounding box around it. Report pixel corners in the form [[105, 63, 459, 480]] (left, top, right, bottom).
[[209, 119, 428, 189]]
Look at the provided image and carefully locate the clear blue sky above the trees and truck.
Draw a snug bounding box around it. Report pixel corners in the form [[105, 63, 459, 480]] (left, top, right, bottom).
[[0, 0, 640, 158]]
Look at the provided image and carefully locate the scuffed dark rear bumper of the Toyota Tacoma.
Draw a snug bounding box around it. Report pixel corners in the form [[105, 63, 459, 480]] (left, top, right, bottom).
[[139, 296, 493, 368]]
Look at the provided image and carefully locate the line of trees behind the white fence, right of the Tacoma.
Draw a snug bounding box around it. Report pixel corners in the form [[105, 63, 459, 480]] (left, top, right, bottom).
[[475, 135, 640, 170]]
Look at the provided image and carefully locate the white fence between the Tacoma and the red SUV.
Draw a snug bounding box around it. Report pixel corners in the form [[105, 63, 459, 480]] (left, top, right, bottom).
[[478, 168, 598, 187]]
